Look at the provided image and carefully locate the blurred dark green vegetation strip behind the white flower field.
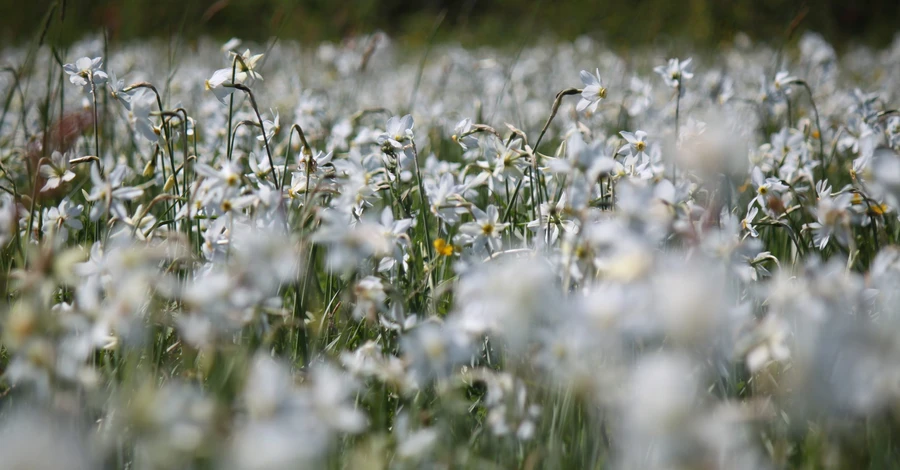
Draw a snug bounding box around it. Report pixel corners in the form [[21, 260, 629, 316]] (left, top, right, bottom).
[[7, 0, 900, 48]]
